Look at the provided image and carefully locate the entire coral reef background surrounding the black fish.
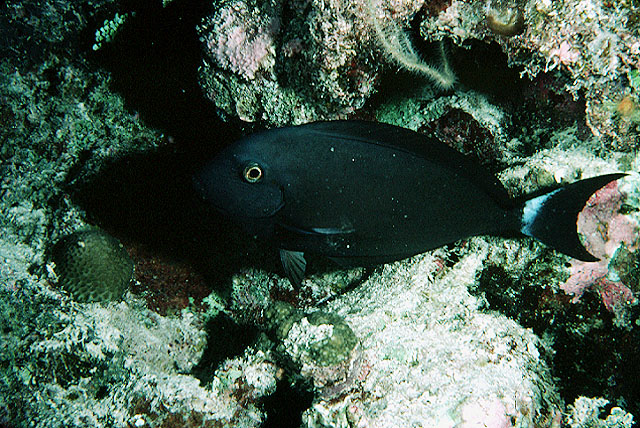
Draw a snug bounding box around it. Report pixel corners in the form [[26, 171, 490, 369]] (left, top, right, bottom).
[[0, 0, 640, 428]]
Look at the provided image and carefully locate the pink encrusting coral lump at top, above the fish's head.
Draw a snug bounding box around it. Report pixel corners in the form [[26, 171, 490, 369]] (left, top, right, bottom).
[[203, 1, 280, 79]]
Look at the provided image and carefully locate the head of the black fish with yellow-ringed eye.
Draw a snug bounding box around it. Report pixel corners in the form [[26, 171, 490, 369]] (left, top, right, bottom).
[[194, 135, 284, 219]]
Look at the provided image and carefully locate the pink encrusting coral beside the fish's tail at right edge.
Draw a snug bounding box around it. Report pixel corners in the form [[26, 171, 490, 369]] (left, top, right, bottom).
[[560, 181, 640, 314]]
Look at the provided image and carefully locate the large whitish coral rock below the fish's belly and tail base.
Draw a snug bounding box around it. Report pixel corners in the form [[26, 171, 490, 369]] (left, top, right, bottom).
[[304, 251, 560, 427]]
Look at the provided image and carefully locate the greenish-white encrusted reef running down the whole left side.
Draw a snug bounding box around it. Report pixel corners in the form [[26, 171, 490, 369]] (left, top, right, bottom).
[[0, 1, 276, 427]]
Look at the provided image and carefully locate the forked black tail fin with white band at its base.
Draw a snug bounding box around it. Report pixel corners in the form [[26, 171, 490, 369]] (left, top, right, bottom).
[[519, 173, 627, 262]]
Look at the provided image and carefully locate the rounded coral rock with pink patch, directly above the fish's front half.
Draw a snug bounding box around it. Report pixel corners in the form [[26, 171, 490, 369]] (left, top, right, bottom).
[[199, 0, 432, 125]]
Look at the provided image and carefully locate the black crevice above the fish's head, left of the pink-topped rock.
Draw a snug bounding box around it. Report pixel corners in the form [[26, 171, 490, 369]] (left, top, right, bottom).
[[82, 0, 238, 149]]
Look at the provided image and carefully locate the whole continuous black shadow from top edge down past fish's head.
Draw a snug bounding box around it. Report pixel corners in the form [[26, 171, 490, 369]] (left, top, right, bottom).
[[67, 0, 277, 283]]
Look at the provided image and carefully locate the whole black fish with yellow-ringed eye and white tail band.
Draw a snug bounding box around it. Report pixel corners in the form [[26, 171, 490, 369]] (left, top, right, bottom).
[[194, 121, 625, 284]]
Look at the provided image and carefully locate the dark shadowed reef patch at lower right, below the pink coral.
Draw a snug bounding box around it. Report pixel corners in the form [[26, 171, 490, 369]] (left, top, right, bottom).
[[471, 261, 640, 417]]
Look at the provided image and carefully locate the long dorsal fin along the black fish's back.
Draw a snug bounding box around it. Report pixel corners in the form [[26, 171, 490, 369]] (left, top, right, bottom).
[[298, 120, 509, 207]]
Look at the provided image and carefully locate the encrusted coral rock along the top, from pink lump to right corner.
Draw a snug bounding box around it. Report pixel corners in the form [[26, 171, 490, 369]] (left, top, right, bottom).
[[200, 0, 640, 150]]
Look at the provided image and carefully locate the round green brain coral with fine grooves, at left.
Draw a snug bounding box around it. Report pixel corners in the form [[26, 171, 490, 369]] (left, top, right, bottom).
[[51, 229, 133, 303]]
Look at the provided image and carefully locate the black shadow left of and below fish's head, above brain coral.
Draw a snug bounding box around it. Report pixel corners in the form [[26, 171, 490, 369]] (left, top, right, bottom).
[[70, 148, 278, 286]]
